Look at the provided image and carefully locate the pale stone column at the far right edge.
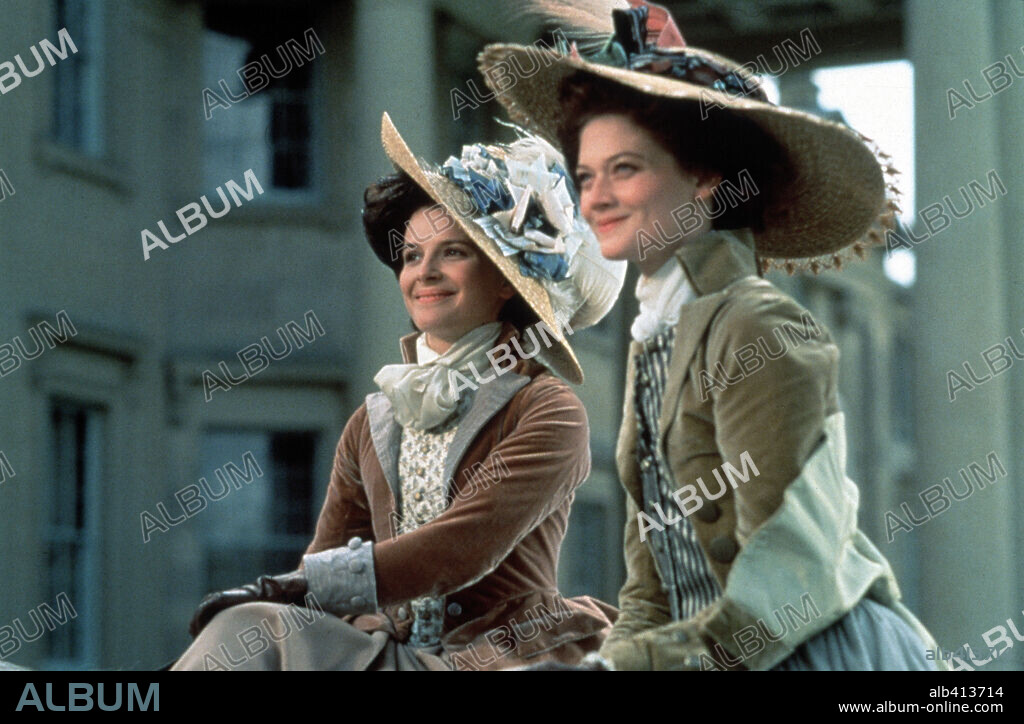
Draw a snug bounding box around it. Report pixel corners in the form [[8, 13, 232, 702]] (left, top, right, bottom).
[[909, 0, 1011, 668]]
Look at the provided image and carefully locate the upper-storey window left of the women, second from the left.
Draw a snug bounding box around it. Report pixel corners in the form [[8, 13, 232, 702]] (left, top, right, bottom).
[[203, 8, 324, 202]]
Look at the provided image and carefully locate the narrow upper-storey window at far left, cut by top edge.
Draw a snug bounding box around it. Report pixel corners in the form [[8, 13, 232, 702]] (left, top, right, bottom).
[[52, 0, 103, 157]]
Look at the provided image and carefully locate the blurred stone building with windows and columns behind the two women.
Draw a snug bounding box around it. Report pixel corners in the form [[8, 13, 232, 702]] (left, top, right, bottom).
[[0, 0, 1024, 669]]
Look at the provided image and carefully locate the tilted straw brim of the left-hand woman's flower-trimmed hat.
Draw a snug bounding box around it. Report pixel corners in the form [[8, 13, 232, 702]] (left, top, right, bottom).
[[381, 113, 584, 384]]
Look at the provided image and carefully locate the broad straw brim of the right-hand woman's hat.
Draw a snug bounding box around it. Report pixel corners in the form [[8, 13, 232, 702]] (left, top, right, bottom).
[[477, 44, 892, 266]]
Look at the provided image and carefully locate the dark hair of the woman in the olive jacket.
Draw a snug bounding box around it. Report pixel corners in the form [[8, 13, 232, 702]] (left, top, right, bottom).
[[558, 72, 790, 230]]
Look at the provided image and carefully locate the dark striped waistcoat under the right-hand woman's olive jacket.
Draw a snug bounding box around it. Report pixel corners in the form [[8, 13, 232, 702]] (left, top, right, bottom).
[[634, 328, 722, 621]]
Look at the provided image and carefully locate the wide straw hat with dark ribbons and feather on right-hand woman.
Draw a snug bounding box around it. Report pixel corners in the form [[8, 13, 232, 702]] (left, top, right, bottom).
[[478, 0, 899, 273]]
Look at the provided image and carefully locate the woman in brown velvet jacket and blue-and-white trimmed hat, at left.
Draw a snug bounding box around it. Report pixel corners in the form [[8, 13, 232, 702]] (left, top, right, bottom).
[[175, 114, 625, 670]]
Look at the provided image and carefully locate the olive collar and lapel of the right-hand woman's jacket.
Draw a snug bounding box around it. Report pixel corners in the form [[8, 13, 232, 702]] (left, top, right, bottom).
[[655, 229, 758, 450]]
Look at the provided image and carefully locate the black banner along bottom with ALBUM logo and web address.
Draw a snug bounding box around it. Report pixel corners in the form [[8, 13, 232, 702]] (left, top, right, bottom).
[[0, 671, 1021, 721]]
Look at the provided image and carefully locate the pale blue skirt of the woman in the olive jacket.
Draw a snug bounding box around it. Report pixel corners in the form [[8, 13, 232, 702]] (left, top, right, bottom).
[[772, 598, 938, 671]]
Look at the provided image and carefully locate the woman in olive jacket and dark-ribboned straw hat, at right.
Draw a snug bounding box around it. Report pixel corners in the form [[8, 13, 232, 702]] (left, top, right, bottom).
[[480, 0, 936, 670]]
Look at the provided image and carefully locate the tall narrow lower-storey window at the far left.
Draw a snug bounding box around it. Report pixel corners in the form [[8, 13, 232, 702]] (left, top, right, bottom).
[[46, 399, 105, 669]]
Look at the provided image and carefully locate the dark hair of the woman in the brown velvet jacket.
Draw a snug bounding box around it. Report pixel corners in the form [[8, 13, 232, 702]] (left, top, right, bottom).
[[362, 171, 540, 331]]
